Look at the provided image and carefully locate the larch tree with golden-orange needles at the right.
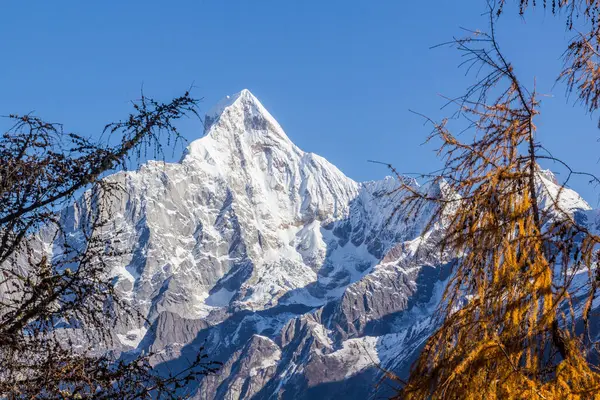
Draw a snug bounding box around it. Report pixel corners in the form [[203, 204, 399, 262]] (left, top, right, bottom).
[[396, 0, 600, 399]]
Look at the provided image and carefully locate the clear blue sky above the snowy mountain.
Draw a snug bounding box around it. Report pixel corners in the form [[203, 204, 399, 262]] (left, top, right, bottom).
[[0, 0, 600, 206]]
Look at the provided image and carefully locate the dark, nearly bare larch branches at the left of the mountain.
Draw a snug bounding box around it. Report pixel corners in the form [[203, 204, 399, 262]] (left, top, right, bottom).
[[0, 92, 218, 399]]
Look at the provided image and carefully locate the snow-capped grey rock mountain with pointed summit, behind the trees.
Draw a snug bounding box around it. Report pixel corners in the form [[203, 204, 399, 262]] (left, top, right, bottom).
[[55, 90, 595, 399]]
